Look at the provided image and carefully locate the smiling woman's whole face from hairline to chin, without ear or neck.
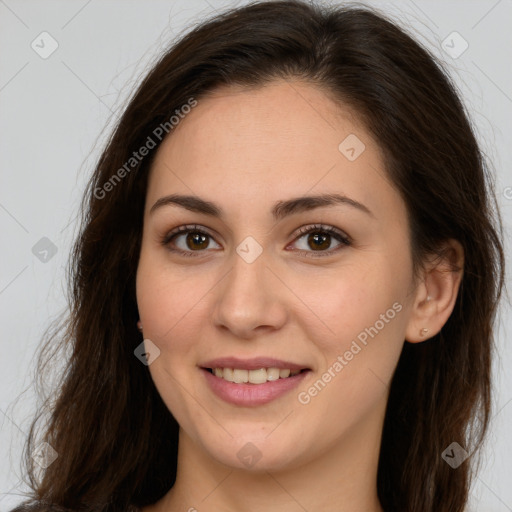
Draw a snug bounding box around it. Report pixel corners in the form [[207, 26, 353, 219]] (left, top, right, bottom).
[[137, 81, 420, 469]]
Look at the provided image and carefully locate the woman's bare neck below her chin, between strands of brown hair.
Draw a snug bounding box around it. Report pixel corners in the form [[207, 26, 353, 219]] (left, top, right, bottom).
[[150, 400, 384, 512]]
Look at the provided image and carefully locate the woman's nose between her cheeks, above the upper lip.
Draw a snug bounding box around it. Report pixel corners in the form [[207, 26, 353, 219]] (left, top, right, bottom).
[[209, 252, 290, 340]]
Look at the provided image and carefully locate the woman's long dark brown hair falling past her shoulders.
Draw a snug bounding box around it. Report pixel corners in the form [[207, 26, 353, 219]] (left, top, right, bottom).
[[10, 1, 504, 512]]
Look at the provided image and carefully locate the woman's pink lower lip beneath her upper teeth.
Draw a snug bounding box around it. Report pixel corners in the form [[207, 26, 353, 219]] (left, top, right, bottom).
[[201, 368, 309, 407]]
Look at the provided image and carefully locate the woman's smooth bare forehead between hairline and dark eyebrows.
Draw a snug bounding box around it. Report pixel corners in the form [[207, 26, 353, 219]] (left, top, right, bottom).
[[148, 81, 397, 221]]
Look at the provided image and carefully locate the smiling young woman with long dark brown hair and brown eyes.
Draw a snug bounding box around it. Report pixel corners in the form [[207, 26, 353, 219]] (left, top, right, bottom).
[[10, 1, 504, 512]]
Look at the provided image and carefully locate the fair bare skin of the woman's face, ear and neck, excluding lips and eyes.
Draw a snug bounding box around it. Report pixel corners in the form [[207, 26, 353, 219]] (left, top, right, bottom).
[[137, 80, 463, 512]]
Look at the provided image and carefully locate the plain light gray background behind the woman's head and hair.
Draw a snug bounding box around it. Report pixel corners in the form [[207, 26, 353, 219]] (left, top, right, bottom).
[[0, 0, 512, 512]]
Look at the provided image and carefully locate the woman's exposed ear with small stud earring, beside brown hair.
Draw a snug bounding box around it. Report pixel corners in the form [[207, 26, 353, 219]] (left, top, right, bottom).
[[405, 239, 464, 343]]
